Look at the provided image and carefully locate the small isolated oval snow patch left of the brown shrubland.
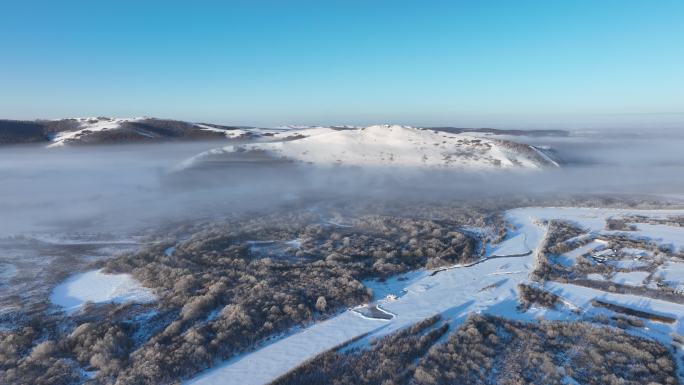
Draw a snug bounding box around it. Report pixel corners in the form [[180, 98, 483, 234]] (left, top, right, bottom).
[[50, 270, 156, 313]]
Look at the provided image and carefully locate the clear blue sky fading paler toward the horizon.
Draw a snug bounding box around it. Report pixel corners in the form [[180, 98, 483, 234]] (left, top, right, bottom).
[[0, 0, 684, 125]]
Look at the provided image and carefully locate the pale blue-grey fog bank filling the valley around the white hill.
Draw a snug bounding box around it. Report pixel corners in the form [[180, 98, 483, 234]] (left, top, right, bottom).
[[0, 130, 684, 237]]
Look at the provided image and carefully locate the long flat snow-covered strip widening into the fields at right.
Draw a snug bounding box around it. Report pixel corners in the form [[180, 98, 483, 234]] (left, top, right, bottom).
[[187, 208, 684, 385]]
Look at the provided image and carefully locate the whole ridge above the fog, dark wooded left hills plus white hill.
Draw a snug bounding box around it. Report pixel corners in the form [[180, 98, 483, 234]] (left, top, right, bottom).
[[0, 117, 558, 169]]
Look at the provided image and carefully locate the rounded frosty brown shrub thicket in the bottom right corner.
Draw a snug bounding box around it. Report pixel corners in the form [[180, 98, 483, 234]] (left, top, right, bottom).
[[411, 315, 678, 385]]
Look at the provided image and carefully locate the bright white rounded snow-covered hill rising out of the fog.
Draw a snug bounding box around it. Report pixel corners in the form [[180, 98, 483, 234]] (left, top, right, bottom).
[[186, 125, 558, 169]]
